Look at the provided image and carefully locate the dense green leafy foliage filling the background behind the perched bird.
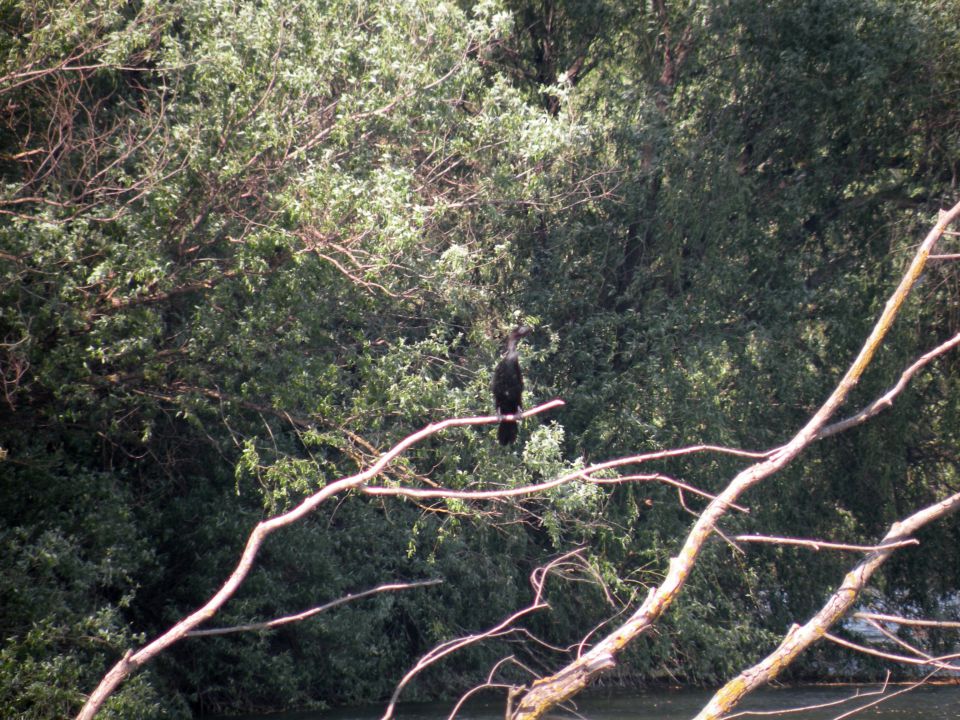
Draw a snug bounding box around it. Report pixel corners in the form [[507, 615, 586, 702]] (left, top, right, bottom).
[[0, 0, 960, 718]]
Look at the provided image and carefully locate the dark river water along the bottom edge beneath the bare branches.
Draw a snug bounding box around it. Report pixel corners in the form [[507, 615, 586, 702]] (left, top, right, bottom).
[[280, 685, 960, 720]]
